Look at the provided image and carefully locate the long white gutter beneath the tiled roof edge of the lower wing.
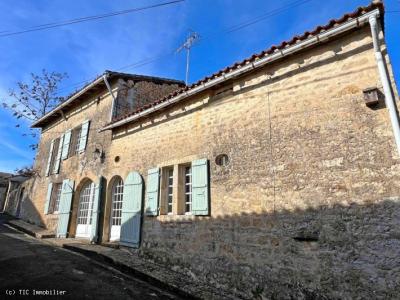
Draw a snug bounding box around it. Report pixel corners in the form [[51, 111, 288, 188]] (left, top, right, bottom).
[[99, 9, 382, 132]]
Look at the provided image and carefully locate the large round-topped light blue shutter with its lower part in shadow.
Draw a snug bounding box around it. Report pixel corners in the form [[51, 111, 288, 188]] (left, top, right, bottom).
[[120, 172, 143, 248]]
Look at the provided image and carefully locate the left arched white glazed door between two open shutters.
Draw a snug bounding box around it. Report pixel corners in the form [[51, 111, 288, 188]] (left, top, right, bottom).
[[76, 181, 95, 238]]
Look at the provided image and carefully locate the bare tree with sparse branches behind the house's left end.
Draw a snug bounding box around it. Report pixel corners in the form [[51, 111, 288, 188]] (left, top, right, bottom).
[[2, 69, 67, 149]]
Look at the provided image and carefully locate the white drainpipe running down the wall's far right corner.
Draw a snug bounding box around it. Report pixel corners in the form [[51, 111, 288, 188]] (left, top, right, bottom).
[[369, 15, 400, 155]]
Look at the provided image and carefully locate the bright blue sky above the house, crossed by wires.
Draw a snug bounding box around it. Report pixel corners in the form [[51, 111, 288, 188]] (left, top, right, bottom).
[[0, 0, 400, 172]]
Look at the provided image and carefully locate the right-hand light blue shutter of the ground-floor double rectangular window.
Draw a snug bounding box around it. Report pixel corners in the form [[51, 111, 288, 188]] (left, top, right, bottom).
[[192, 159, 209, 216]]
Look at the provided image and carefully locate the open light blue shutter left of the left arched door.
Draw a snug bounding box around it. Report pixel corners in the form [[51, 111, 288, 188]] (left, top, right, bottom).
[[56, 179, 74, 238]]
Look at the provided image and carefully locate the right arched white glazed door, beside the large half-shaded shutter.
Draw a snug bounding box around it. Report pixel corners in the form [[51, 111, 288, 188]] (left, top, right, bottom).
[[110, 177, 124, 242]]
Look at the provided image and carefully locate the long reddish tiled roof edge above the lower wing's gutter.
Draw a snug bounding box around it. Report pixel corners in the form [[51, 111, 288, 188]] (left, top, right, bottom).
[[106, 2, 384, 126]]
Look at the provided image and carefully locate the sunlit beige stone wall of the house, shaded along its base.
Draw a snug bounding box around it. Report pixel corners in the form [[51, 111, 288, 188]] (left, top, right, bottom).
[[25, 27, 400, 299]]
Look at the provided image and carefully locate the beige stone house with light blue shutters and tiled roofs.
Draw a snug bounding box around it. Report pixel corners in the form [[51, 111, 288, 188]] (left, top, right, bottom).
[[14, 3, 400, 299]]
